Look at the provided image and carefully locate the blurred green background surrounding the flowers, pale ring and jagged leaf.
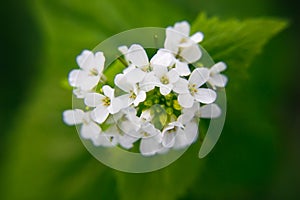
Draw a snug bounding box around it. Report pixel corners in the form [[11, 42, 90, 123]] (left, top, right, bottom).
[[0, 0, 300, 200]]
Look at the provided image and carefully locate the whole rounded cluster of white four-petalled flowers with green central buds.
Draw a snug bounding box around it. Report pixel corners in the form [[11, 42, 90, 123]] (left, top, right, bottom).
[[63, 21, 227, 156]]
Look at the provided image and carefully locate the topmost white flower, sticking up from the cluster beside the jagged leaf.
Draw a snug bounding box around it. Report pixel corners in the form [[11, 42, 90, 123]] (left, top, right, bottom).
[[164, 21, 203, 63]]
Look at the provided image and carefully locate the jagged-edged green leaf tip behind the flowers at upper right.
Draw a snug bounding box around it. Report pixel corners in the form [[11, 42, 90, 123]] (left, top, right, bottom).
[[192, 14, 288, 82]]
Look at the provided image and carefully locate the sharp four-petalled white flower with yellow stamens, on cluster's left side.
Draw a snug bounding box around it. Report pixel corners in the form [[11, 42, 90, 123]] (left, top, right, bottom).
[[84, 85, 121, 124]]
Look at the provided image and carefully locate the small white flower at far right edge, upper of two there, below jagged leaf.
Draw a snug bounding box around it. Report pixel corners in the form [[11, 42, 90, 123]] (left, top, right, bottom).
[[208, 62, 228, 89]]
